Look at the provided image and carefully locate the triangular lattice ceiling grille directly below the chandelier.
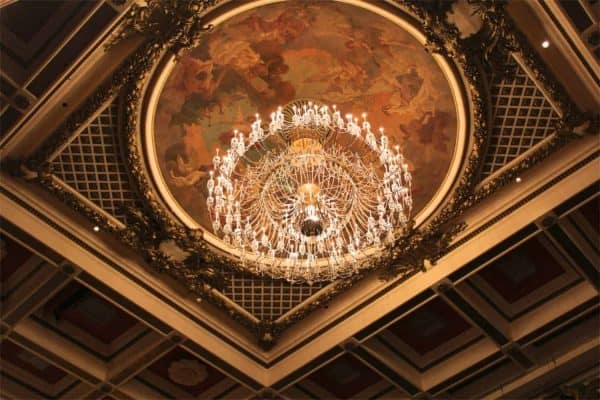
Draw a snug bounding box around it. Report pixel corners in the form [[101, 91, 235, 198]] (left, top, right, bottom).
[[223, 274, 324, 321]]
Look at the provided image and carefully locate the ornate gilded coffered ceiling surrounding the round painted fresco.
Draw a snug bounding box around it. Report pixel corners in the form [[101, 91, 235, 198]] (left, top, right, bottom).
[[0, 0, 600, 399]]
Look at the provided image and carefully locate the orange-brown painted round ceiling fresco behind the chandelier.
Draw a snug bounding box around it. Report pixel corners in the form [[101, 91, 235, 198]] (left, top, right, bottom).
[[154, 1, 457, 227]]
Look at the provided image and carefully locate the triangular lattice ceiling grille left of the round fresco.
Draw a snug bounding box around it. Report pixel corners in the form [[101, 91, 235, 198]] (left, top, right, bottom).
[[51, 98, 138, 223]]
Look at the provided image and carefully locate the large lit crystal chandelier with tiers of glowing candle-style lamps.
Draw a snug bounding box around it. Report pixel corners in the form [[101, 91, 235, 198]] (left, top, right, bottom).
[[206, 100, 412, 284]]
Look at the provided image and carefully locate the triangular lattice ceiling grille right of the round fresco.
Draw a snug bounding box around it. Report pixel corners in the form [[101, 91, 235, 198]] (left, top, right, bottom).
[[482, 55, 559, 178]]
